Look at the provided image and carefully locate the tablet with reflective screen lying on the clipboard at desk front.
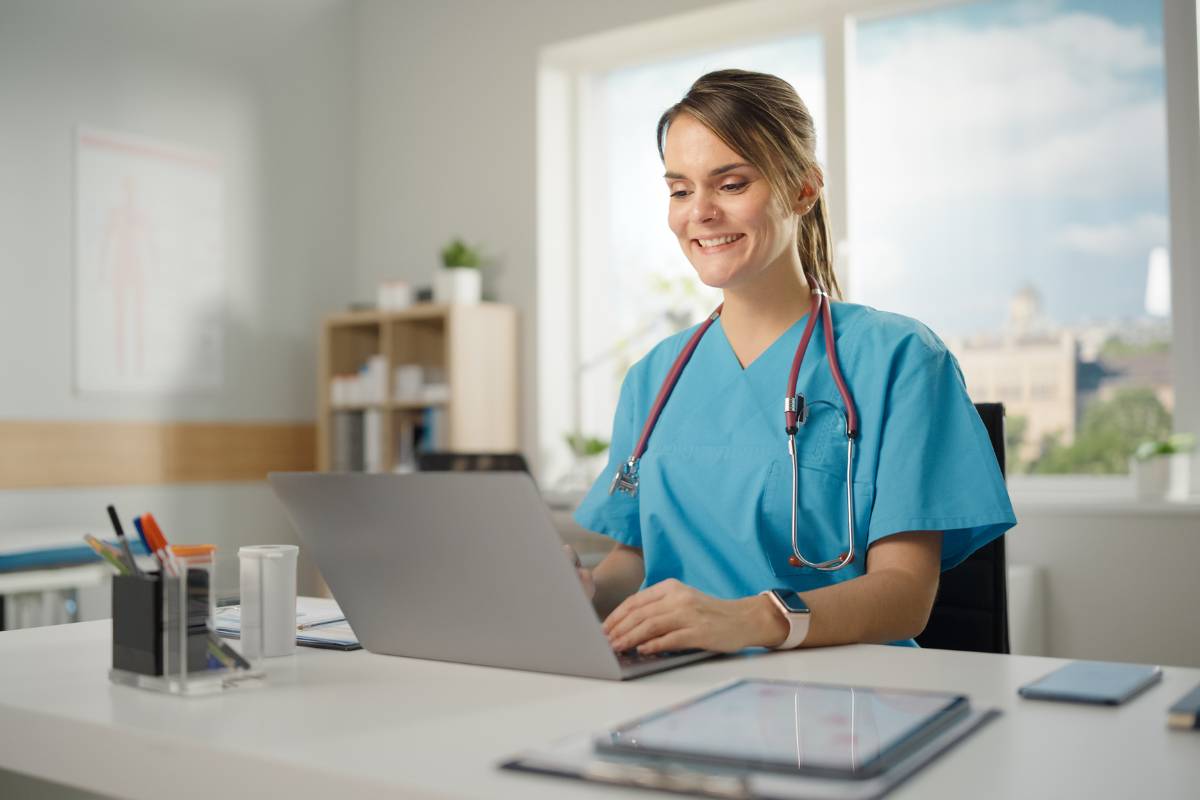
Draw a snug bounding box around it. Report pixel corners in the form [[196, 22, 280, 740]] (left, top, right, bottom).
[[595, 680, 970, 778]]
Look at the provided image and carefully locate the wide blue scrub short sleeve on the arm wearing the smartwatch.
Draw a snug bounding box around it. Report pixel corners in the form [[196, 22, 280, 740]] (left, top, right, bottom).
[[868, 348, 1016, 571]]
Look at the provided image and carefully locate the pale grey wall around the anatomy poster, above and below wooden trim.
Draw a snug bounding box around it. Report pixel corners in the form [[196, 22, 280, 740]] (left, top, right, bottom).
[[0, 0, 355, 599]]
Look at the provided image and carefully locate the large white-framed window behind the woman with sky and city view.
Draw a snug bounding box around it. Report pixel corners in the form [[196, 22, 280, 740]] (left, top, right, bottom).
[[538, 0, 1200, 491]]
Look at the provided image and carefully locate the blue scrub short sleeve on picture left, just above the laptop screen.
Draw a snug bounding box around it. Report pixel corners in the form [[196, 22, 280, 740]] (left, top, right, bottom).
[[575, 369, 642, 547]]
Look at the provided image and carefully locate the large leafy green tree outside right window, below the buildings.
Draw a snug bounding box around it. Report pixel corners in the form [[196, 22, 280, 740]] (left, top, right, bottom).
[[1030, 387, 1171, 475]]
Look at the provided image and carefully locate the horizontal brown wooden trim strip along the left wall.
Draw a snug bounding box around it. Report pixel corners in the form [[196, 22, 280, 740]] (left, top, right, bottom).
[[0, 421, 316, 489]]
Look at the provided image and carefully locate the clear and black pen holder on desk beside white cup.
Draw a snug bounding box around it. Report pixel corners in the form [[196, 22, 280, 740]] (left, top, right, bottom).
[[108, 545, 263, 694]]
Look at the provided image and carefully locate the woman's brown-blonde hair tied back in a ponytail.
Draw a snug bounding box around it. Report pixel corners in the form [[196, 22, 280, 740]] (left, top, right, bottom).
[[656, 70, 841, 299]]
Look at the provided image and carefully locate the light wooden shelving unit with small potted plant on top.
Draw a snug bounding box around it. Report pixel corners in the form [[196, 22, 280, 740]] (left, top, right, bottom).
[[317, 303, 520, 471]]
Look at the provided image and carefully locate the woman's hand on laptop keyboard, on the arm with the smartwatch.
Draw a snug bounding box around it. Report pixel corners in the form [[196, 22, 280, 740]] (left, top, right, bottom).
[[604, 578, 787, 654]]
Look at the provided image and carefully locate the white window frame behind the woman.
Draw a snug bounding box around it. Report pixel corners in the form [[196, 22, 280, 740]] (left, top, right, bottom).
[[535, 0, 1200, 499]]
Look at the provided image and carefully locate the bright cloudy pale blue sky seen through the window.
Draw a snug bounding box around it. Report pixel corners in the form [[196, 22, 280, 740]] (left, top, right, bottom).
[[595, 0, 1168, 359]]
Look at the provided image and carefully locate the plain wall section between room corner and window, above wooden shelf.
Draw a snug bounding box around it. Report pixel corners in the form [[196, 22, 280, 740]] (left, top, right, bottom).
[[355, 0, 719, 470]]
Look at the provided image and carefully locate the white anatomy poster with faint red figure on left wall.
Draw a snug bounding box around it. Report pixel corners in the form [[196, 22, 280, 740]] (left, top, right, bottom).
[[74, 128, 226, 393]]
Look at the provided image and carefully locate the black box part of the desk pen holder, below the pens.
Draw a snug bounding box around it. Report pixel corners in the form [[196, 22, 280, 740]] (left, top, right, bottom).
[[113, 570, 209, 675]]
